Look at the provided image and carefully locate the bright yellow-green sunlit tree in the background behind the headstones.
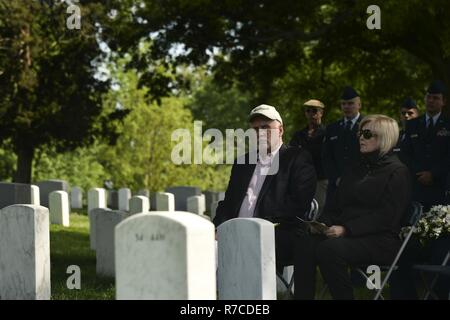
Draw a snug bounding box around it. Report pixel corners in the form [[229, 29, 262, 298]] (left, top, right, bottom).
[[98, 59, 231, 191]]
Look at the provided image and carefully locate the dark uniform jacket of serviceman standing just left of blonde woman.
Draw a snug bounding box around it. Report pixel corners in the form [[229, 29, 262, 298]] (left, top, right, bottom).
[[322, 115, 364, 184]]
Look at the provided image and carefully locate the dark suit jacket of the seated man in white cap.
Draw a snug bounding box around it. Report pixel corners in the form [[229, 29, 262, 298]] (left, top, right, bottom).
[[214, 145, 317, 227]]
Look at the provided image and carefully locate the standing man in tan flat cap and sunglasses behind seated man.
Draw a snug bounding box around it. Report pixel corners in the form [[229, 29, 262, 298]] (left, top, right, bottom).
[[289, 99, 328, 212]]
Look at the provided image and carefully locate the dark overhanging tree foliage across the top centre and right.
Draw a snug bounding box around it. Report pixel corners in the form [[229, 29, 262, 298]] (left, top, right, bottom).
[[110, 0, 450, 115]]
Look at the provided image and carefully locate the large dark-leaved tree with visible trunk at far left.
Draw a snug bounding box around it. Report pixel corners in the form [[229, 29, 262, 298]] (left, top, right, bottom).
[[0, 0, 127, 183]]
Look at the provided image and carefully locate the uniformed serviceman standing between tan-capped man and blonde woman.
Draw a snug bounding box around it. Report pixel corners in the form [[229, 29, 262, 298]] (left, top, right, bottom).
[[322, 87, 363, 209]]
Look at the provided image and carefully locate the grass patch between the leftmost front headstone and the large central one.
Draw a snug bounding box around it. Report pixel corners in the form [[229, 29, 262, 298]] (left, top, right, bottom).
[[50, 210, 115, 300]]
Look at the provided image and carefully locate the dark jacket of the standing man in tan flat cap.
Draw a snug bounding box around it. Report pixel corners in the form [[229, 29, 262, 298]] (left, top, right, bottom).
[[289, 124, 325, 180]]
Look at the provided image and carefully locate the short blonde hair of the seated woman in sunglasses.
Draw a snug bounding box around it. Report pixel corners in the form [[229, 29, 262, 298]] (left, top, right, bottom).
[[359, 114, 399, 156]]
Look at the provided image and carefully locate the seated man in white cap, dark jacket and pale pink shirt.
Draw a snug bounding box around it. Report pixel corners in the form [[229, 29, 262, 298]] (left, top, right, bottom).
[[213, 105, 316, 298]]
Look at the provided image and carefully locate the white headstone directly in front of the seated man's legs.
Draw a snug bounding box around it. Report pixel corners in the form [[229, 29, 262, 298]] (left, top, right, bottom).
[[217, 218, 277, 300]]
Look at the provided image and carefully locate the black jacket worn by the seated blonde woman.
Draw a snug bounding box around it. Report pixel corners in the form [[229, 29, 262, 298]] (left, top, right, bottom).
[[320, 153, 411, 238]]
